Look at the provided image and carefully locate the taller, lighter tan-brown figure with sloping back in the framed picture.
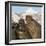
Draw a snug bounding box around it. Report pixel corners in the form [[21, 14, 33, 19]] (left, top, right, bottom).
[[26, 15, 41, 39]]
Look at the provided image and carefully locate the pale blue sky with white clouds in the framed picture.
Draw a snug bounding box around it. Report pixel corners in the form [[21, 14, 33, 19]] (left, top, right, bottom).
[[12, 6, 41, 14]]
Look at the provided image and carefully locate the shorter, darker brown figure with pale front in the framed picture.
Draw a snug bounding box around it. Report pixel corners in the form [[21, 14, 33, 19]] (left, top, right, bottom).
[[15, 19, 32, 39]]
